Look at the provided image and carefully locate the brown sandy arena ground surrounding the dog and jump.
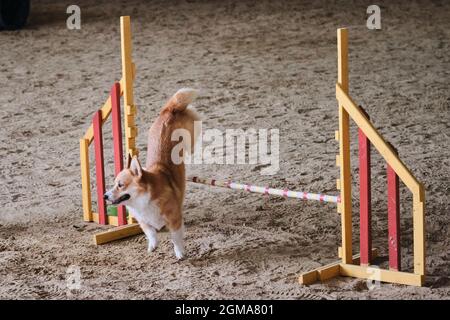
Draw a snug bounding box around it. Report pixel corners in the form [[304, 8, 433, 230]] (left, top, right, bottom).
[[0, 0, 450, 299]]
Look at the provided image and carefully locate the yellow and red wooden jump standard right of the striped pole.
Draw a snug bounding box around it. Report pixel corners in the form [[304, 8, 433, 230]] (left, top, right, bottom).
[[299, 29, 425, 286]]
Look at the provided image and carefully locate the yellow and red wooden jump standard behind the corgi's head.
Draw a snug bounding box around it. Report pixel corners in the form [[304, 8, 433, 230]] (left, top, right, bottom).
[[80, 16, 140, 238]]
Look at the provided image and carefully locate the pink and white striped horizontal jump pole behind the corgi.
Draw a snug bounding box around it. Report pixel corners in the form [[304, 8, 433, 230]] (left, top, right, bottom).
[[186, 177, 341, 203]]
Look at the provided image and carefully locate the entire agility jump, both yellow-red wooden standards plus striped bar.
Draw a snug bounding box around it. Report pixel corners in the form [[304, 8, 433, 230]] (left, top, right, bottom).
[[80, 17, 425, 286]]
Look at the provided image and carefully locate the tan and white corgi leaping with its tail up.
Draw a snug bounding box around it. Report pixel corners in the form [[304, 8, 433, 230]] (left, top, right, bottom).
[[104, 88, 199, 260]]
